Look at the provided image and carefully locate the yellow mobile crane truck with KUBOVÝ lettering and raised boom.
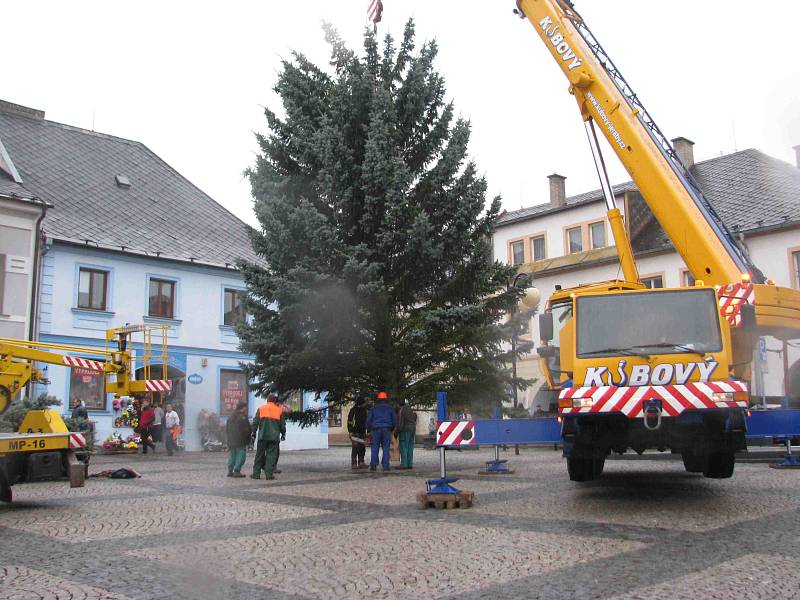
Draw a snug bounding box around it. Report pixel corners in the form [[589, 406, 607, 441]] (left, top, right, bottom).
[[515, 0, 800, 481]]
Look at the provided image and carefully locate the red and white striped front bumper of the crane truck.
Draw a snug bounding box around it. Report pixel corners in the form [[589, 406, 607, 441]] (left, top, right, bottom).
[[558, 381, 747, 419]]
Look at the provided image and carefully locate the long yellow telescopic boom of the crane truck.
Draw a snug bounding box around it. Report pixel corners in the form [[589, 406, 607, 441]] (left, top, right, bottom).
[[517, 0, 763, 285]]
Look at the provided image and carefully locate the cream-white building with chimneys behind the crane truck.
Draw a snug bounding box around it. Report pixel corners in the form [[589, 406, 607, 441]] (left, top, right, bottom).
[[493, 138, 800, 410]]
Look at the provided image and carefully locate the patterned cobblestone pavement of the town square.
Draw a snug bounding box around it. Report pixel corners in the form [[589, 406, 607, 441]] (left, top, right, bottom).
[[0, 448, 800, 600]]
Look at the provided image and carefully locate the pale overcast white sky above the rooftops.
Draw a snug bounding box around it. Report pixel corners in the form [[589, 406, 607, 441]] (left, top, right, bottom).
[[0, 0, 800, 223]]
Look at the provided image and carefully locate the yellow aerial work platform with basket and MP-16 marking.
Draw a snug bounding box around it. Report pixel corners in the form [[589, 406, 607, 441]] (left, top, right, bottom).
[[0, 325, 171, 502]]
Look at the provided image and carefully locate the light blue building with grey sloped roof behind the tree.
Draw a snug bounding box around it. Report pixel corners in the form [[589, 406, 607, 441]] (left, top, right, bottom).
[[0, 101, 327, 450]]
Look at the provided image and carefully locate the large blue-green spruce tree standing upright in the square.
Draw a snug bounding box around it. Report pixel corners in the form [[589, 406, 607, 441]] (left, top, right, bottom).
[[239, 21, 530, 422]]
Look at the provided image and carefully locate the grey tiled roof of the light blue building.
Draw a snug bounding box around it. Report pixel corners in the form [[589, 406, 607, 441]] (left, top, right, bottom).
[[0, 111, 260, 266]]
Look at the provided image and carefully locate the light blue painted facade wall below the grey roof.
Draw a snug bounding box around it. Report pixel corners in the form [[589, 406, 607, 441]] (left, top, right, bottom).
[[37, 242, 328, 450]]
